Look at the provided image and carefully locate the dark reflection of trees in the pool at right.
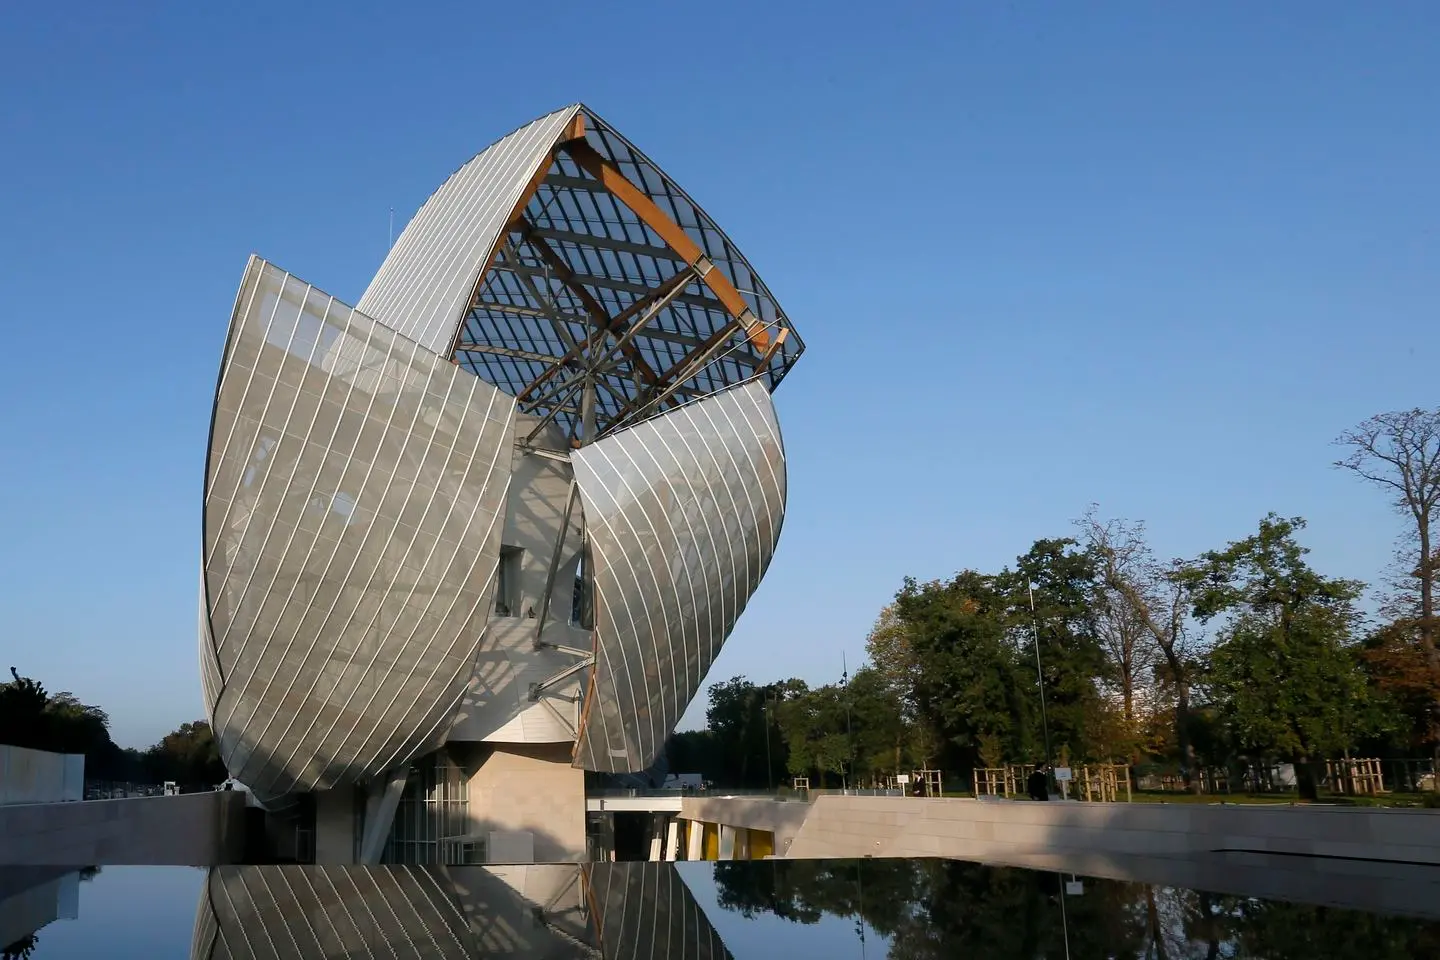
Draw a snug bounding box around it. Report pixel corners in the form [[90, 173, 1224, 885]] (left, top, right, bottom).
[[714, 859, 1440, 960]]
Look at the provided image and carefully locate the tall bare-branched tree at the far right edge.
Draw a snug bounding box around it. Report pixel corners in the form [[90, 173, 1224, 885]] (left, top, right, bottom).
[[1335, 407, 1440, 763]]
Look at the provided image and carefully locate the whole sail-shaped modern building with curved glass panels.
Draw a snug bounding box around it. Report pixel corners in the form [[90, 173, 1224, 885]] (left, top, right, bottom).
[[200, 104, 804, 862]]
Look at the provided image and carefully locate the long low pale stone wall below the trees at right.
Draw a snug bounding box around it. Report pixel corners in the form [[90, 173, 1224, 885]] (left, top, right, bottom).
[[681, 796, 1440, 865]]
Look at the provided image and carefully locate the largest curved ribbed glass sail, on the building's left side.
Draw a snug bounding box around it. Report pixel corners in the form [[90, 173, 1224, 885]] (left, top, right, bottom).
[[200, 258, 514, 797]]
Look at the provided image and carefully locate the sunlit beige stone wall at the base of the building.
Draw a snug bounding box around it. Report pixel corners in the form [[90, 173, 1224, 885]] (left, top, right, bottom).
[[467, 744, 585, 862]]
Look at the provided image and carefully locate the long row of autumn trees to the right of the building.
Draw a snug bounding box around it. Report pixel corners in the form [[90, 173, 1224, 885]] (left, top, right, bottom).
[[667, 409, 1440, 796]]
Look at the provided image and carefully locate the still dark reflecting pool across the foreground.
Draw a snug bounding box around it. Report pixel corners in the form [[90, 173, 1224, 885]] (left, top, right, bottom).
[[0, 859, 1440, 960]]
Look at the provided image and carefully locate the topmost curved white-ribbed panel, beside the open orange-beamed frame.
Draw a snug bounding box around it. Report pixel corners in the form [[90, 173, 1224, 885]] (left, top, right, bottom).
[[356, 104, 580, 354]]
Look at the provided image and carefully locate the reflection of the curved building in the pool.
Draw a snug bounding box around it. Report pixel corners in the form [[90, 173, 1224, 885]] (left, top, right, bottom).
[[192, 864, 730, 960]]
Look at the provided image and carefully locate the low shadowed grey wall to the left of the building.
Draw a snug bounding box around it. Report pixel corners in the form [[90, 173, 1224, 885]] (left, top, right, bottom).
[[0, 790, 245, 866]]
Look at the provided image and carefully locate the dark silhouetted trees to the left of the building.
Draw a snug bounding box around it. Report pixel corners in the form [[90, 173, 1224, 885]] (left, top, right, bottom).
[[0, 666, 226, 787]]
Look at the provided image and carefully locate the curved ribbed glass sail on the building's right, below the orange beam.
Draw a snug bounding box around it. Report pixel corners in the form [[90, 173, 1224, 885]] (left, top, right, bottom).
[[572, 380, 785, 773]]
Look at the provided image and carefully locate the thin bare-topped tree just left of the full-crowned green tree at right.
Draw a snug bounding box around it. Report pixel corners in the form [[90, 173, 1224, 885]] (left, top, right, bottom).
[[1077, 507, 1200, 790]]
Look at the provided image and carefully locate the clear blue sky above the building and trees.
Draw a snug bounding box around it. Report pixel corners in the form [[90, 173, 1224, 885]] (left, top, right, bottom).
[[0, 0, 1440, 746]]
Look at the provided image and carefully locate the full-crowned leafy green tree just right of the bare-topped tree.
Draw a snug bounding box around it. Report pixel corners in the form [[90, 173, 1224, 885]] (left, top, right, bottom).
[[1187, 514, 1371, 799]]
